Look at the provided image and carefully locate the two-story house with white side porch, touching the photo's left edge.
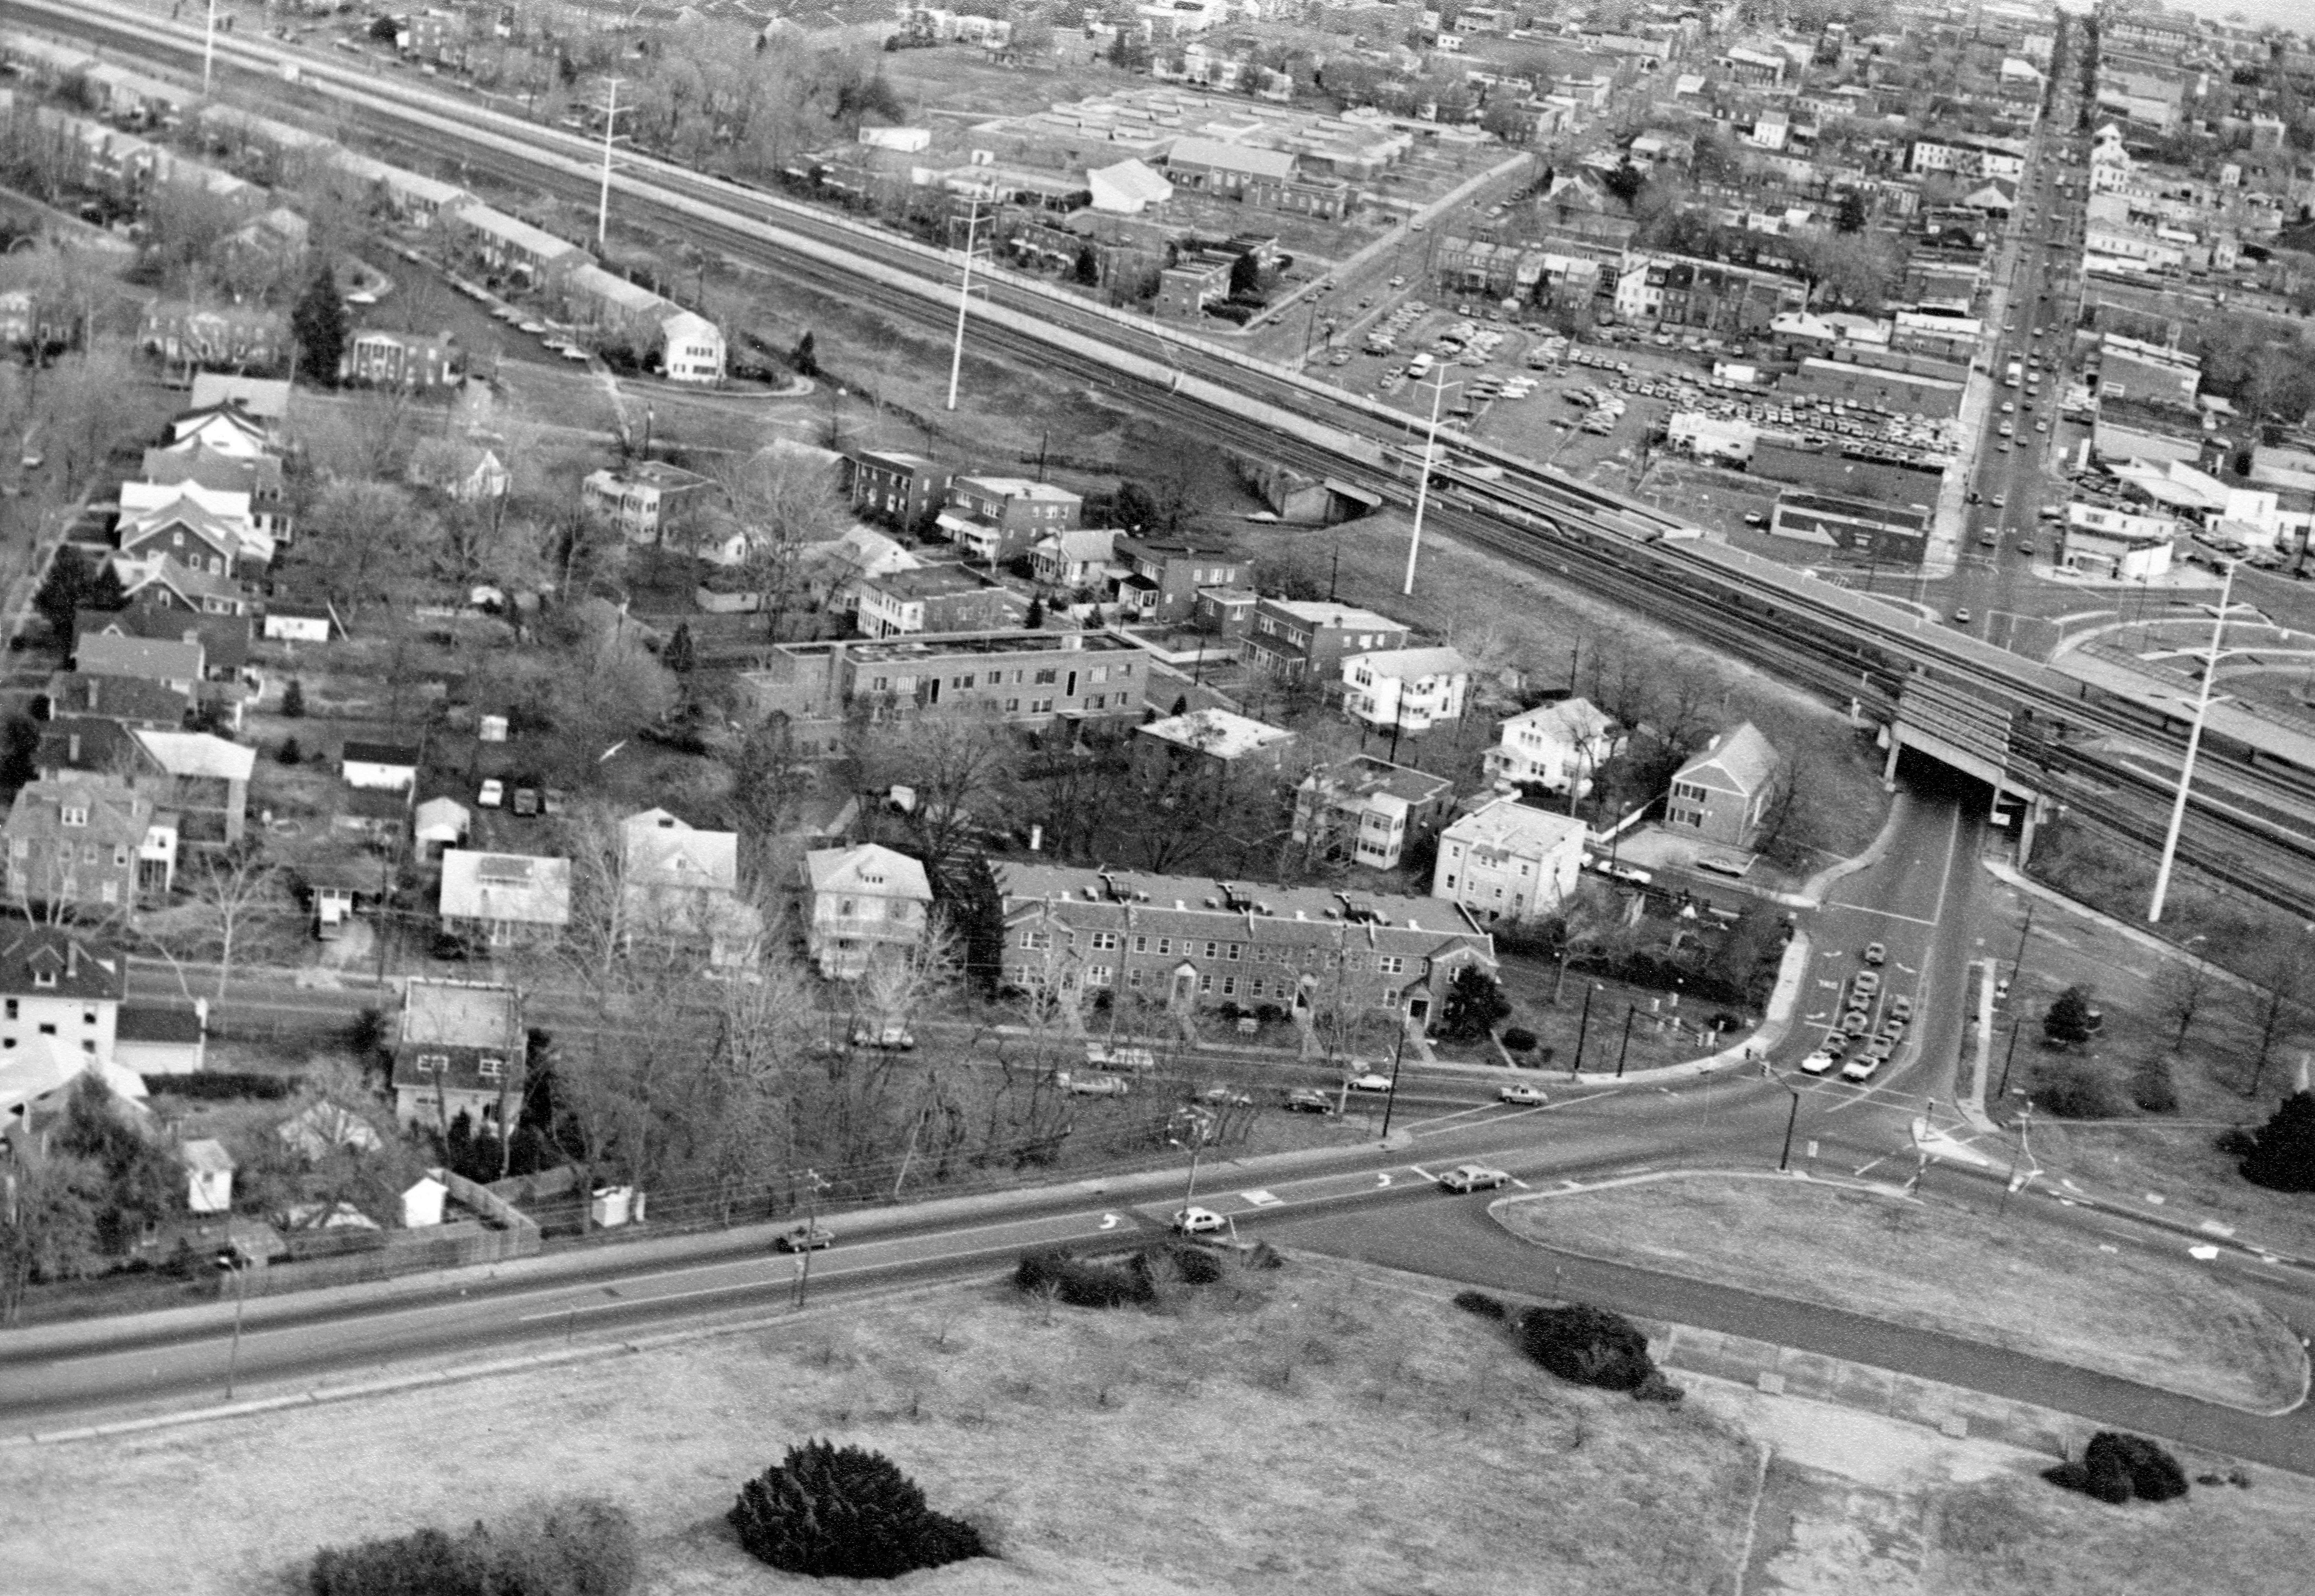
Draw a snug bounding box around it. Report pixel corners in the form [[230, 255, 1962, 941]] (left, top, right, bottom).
[[0, 777, 176, 916]]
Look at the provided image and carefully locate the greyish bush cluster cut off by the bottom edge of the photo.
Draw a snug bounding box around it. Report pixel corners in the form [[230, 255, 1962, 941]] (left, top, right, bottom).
[[306, 1496, 641, 1596]]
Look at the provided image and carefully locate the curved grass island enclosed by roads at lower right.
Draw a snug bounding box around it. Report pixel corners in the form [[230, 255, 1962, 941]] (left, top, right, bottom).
[[1496, 1175, 2306, 1409]]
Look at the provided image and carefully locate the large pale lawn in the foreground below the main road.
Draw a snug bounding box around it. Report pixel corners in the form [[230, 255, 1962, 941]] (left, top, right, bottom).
[[0, 1261, 1755, 1596]]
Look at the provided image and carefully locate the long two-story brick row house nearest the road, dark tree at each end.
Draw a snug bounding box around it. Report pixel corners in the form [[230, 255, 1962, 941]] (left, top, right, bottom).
[[998, 863, 1496, 1029]]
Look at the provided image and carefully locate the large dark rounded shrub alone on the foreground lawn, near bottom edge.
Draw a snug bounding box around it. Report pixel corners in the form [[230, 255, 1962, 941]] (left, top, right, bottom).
[[729, 1441, 986, 1580]]
